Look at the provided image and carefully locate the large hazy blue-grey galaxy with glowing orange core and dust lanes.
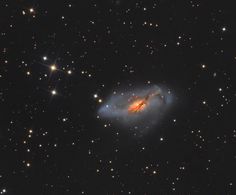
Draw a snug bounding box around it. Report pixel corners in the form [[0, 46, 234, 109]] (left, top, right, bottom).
[[98, 85, 173, 131]]
